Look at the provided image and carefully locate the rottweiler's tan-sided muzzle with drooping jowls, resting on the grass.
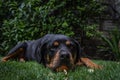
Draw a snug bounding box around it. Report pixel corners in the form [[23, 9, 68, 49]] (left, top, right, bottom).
[[47, 52, 74, 72]]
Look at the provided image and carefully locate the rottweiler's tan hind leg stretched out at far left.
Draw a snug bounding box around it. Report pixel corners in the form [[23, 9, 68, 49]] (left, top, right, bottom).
[[2, 48, 25, 62]]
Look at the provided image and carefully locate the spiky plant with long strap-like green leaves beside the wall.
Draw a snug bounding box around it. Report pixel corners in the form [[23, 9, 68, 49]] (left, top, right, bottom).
[[101, 28, 120, 61]]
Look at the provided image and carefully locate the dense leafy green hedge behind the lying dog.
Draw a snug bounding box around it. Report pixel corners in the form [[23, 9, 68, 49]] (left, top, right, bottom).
[[0, 0, 103, 53]]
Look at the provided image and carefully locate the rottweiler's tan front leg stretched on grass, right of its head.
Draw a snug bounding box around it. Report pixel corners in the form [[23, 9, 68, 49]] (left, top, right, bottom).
[[76, 58, 102, 69]]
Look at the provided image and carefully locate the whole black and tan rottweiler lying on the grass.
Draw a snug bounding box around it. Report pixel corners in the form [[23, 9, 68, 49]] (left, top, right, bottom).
[[2, 34, 101, 71]]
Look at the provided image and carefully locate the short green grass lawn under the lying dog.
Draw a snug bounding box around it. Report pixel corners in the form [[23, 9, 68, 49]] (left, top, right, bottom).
[[0, 57, 120, 80]]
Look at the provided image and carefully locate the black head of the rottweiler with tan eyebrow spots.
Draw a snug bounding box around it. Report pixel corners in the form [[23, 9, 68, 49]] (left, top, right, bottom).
[[38, 34, 81, 71]]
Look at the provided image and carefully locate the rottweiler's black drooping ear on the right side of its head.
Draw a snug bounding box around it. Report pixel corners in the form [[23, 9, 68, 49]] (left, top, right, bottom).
[[73, 39, 85, 62]]
